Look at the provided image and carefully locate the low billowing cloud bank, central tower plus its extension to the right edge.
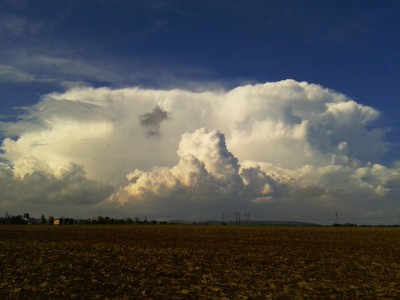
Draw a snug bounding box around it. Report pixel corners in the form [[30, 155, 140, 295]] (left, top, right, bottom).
[[109, 128, 400, 221]]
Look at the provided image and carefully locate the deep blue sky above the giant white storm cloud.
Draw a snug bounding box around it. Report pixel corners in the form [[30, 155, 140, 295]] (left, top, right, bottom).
[[0, 1, 400, 105]]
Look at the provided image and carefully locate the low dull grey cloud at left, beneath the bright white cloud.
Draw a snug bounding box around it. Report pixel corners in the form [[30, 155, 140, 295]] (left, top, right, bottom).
[[0, 163, 114, 213]]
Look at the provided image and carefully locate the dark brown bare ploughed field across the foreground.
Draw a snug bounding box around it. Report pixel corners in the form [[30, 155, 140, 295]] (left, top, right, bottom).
[[0, 225, 400, 299]]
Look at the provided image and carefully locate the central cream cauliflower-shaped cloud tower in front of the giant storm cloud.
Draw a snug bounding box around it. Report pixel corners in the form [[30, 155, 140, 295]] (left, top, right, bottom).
[[109, 128, 273, 216]]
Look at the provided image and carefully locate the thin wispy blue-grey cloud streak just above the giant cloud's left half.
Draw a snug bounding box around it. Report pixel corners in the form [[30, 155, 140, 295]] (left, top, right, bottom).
[[0, 46, 218, 90]]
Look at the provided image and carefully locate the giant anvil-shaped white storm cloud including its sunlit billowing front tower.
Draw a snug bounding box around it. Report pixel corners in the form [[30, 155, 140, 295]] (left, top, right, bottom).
[[0, 80, 400, 223]]
